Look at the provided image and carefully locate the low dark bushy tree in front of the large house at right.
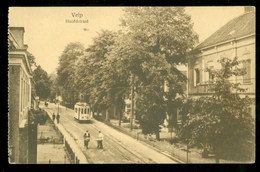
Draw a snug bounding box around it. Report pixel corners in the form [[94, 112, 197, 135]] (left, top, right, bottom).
[[180, 57, 255, 162]]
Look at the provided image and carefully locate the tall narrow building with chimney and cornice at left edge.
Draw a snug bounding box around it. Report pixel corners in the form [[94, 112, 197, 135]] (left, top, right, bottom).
[[8, 27, 32, 164]]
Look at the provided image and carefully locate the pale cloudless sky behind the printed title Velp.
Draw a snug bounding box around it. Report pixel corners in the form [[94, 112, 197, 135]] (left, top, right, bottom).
[[8, 6, 244, 74]]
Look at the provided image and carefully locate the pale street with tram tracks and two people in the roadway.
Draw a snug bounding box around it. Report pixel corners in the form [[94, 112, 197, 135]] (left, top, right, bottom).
[[40, 102, 177, 164]]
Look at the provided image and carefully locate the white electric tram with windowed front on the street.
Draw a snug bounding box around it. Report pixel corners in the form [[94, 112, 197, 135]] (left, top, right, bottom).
[[74, 102, 93, 122]]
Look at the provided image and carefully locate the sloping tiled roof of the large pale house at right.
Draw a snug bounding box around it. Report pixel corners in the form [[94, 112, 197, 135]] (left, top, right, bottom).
[[194, 11, 255, 50]]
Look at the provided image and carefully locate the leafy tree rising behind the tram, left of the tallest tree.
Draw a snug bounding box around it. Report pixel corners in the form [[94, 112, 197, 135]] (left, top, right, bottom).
[[75, 30, 125, 120]]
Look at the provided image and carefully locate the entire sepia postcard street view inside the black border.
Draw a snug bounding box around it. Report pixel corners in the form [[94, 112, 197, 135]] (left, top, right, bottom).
[[6, 6, 256, 164]]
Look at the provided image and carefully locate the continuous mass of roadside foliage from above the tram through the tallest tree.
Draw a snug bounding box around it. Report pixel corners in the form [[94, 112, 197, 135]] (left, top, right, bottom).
[[52, 7, 198, 140]]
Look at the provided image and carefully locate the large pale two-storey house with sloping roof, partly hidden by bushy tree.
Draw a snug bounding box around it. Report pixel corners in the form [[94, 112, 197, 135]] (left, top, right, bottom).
[[188, 7, 256, 117]]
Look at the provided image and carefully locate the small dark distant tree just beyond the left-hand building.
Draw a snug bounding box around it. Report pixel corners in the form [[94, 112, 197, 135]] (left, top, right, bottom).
[[33, 65, 50, 99]]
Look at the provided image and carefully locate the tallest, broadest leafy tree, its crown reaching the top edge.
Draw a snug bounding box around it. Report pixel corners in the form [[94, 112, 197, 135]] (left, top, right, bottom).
[[108, 7, 198, 139]]
